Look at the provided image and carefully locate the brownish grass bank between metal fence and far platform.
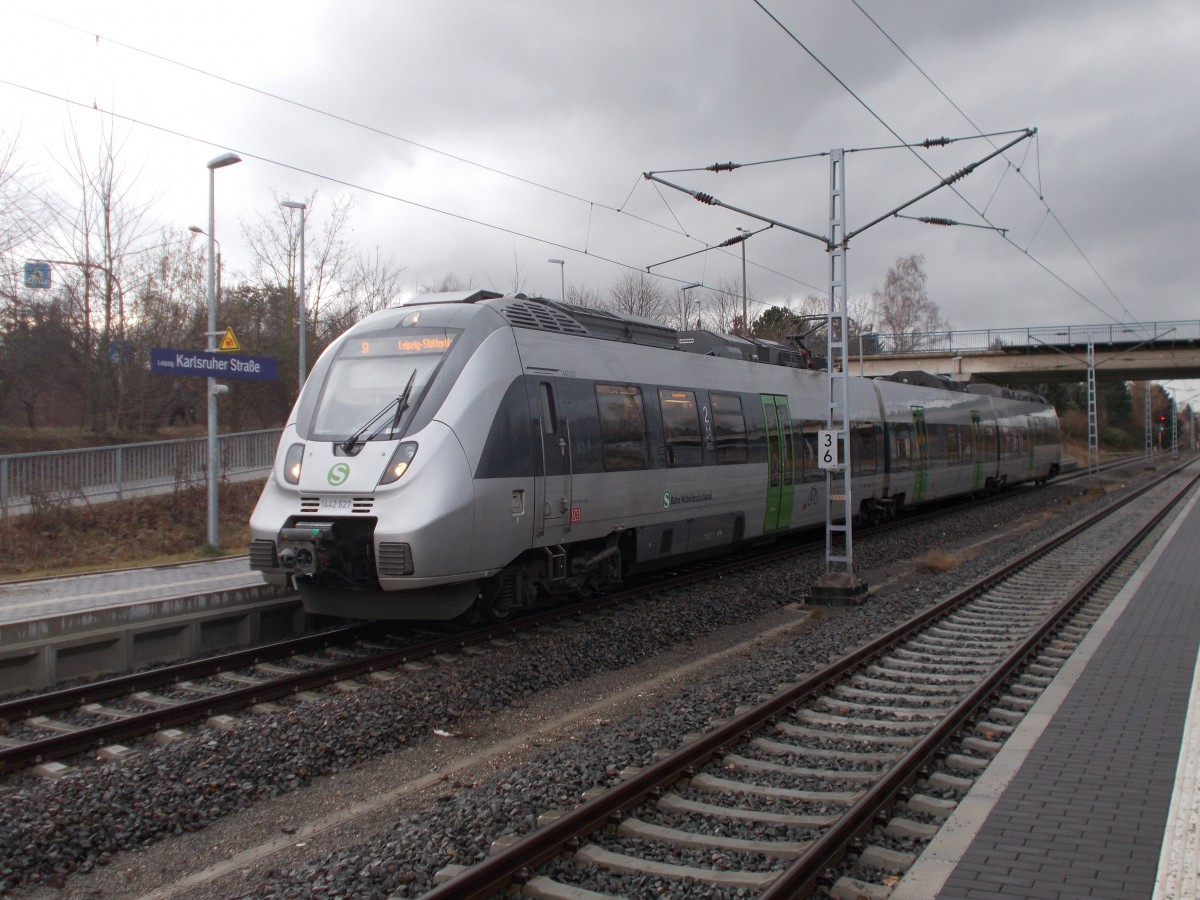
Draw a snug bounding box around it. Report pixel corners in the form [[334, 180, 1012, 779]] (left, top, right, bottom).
[[0, 480, 263, 580]]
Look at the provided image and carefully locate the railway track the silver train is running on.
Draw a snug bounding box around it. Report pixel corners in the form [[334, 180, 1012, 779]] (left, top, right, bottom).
[[0, 453, 1152, 775]]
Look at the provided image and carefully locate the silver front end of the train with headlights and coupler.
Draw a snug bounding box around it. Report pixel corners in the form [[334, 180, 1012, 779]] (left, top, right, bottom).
[[250, 294, 516, 619]]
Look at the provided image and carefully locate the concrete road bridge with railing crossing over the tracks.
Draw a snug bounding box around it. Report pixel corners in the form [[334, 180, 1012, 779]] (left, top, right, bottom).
[[849, 322, 1200, 384]]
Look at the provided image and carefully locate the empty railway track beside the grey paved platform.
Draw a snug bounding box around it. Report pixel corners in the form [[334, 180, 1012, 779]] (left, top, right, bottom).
[[426, 473, 1195, 898]]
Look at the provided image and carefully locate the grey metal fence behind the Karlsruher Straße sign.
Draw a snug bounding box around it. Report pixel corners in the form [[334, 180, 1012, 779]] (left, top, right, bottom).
[[0, 428, 282, 516]]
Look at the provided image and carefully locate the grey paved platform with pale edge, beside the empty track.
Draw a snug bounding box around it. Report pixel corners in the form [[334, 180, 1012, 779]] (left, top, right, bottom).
[[889, 494, 1200, 900]]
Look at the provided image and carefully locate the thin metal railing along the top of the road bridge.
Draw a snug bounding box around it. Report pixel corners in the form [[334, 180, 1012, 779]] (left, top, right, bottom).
[[848, 320, 1200, 356]]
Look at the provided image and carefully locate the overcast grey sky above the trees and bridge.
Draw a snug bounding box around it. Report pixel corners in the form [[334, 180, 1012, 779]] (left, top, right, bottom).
[[0, 0, 1200, 329]]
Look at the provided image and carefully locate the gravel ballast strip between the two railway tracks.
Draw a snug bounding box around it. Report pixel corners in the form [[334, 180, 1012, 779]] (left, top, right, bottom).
[[7, 476, 1152, 898]]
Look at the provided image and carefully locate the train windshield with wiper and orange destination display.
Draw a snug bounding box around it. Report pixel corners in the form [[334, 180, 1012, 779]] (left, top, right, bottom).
[[308, 329, 458, 440]]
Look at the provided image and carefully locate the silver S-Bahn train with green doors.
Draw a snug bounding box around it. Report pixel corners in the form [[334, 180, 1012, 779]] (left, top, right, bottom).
[[250, 290, 1061, 619]]
